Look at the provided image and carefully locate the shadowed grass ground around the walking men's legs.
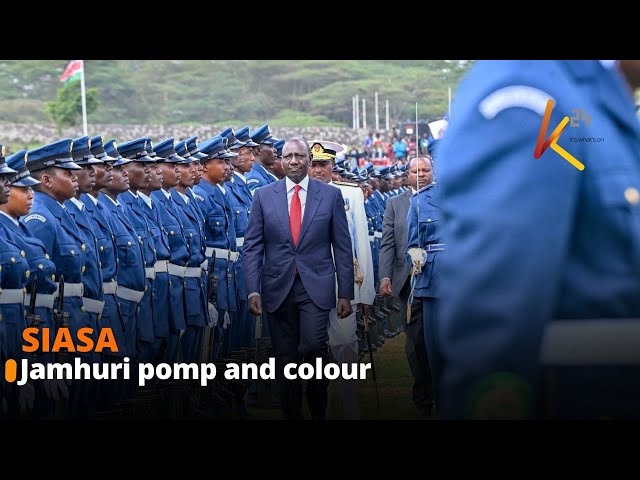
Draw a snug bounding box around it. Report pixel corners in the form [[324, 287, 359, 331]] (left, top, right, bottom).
[[247, 333, 430, 420]]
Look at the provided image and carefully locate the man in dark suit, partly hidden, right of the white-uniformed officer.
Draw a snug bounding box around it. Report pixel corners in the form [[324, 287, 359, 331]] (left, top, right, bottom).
[[379, 157, 433, 416]]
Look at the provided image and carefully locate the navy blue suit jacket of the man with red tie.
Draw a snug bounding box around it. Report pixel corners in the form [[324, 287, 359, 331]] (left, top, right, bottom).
[[243, 178, 354, 312]]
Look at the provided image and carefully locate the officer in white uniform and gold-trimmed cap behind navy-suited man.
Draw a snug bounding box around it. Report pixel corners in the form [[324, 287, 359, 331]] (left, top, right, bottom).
[[308, 140, 376, 420]]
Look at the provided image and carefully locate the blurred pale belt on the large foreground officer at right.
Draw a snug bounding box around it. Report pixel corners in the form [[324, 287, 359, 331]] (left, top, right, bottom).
[[540, 318, 640, 366]]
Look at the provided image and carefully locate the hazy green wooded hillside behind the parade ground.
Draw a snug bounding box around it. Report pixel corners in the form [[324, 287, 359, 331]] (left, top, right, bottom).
[[0, 60, 470, 128]]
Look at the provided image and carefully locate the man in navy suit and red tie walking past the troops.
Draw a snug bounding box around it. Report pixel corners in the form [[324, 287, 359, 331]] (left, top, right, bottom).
[[243, 137, 354, 419]]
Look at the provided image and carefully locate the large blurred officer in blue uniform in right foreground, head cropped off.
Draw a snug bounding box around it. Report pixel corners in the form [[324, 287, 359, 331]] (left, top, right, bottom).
[[440, 60, 640, 418]]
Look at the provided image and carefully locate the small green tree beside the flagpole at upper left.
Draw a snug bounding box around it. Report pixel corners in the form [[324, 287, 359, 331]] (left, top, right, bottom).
[[45, 82, 98, 133]]
